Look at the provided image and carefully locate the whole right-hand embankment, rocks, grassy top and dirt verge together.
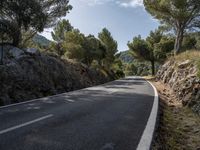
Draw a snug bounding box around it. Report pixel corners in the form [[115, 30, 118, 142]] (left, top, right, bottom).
[[149, 51, 200, 150]]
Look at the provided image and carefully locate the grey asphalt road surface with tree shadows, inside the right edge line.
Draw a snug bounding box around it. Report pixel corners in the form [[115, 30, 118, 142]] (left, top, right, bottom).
[[0, 77, 154, 150]]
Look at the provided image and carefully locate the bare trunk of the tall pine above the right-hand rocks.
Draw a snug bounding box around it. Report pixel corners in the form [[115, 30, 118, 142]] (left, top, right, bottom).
[[174, 29, 184, 55]]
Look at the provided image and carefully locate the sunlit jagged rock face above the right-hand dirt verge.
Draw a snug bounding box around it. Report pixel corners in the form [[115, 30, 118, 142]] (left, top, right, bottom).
[[157, 60, 200, 114]]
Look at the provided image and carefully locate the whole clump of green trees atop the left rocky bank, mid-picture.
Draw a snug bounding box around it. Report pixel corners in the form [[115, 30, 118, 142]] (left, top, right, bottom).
[[49, 20, 124, 79]]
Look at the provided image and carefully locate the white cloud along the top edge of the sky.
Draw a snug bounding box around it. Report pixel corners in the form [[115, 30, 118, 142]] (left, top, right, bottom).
[[80, 0, 143, 7]]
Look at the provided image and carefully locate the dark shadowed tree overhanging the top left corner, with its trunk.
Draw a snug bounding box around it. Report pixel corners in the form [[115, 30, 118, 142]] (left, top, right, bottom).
[[0, 0, 72, 46]]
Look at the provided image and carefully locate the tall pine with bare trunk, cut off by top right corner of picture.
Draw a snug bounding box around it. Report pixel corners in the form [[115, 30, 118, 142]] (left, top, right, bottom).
[[144, 0, 200, 54]]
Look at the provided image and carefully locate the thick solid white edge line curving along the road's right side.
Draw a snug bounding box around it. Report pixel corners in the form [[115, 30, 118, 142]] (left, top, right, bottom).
[[137, 81, 159, 150]]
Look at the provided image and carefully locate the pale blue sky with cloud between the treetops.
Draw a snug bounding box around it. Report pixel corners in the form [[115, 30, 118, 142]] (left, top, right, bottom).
[[43, 0, 159, 51]]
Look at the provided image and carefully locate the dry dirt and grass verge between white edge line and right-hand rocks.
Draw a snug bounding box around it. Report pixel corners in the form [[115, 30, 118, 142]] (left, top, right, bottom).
[[148, 79, 200, 150]]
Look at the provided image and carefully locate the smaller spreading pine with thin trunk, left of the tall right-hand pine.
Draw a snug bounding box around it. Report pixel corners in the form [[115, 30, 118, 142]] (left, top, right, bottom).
[[128, 28, 174, 75]]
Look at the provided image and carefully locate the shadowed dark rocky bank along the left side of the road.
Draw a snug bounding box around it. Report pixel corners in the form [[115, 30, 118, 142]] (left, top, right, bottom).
[[0, 47, 111, 105]]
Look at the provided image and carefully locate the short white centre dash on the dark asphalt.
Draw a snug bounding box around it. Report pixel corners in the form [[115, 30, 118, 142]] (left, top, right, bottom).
[[0, 114, 53, 135]]
